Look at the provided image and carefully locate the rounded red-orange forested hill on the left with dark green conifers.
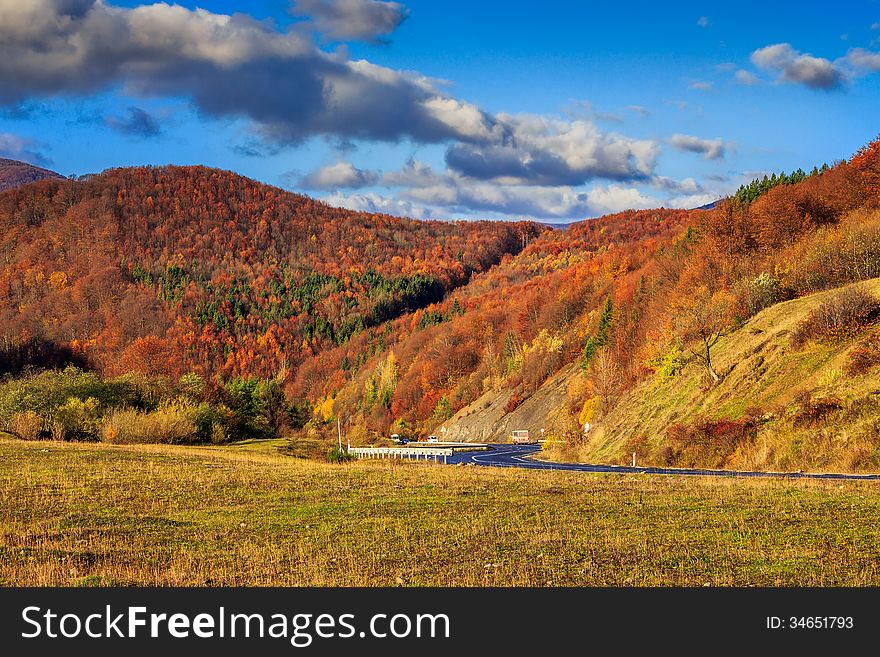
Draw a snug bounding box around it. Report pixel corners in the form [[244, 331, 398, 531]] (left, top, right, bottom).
[[0, 167, 540, 379]]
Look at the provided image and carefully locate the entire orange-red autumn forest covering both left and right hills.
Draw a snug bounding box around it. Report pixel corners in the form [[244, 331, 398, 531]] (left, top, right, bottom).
[[0, 135, 880, 462]]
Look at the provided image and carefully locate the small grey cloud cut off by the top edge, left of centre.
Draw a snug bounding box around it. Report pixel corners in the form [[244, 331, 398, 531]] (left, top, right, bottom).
[[291, 0, 409, 41]]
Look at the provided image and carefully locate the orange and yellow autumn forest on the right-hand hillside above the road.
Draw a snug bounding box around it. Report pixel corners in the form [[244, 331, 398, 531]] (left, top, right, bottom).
[[310, 136, 880, 443]]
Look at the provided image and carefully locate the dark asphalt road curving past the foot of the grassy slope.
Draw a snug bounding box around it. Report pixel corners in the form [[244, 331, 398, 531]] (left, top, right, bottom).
[[447, 445, 880, 481]]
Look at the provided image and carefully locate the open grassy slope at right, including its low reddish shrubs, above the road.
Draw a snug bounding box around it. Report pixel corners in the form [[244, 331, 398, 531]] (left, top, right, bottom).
[[578, 278, 880, 471]]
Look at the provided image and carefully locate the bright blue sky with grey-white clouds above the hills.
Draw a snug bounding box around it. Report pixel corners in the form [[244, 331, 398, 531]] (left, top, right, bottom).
[[0, 0, 880, 221]]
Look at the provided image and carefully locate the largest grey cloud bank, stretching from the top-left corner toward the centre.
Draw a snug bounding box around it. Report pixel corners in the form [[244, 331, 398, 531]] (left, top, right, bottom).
[[0, 0, 482, 143]]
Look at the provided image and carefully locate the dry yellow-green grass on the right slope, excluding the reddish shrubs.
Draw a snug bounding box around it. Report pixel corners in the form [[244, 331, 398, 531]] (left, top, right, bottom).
[[584, 279, 880, 472]]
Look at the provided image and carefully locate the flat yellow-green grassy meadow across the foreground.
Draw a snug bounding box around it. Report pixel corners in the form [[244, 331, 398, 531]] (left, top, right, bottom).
[[0, 438, 880, 586]]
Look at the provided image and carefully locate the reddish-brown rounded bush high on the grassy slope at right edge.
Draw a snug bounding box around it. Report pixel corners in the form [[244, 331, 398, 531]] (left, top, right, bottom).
[[792, 287, 880, 347]]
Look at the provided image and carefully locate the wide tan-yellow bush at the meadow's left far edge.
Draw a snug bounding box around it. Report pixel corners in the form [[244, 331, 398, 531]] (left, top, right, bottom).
[[102, 402, 199, 444]]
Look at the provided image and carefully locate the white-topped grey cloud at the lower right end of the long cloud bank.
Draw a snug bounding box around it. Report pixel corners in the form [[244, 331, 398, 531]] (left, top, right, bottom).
[[446, 114, 660, 185]]
